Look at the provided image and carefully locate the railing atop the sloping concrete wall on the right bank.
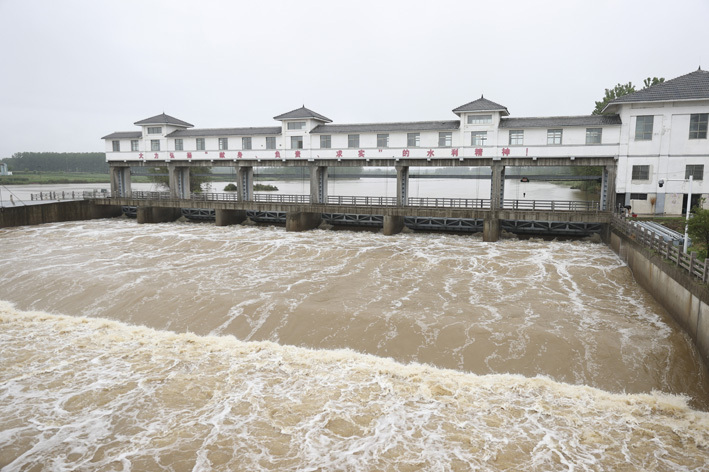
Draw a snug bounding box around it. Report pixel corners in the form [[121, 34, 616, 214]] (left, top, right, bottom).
[[611, 215, 709, 283]]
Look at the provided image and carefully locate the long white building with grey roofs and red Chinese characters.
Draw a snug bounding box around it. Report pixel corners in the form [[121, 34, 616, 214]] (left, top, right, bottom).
[[103, 69, 709, 214]]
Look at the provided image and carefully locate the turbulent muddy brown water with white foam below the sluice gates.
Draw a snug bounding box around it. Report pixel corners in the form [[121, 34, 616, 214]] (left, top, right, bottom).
[[0, 219, 709, 471]]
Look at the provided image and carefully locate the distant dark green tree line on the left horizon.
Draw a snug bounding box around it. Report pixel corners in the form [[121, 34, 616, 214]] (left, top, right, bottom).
[[2, 152, 108, 174]]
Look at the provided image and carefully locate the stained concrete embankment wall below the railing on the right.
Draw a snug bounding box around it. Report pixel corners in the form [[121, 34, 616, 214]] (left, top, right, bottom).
[[610, 230, 709, 366]]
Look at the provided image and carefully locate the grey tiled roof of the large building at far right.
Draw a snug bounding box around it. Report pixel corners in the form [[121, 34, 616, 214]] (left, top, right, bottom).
[[603, 69, 709, 111]]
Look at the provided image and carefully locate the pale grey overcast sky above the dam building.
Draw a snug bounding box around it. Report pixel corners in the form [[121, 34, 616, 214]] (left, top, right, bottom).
[[0, 0, 709, 158]]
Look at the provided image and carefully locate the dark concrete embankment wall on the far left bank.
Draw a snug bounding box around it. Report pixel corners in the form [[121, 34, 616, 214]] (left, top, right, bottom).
[[0, 200, 121, 228]]
